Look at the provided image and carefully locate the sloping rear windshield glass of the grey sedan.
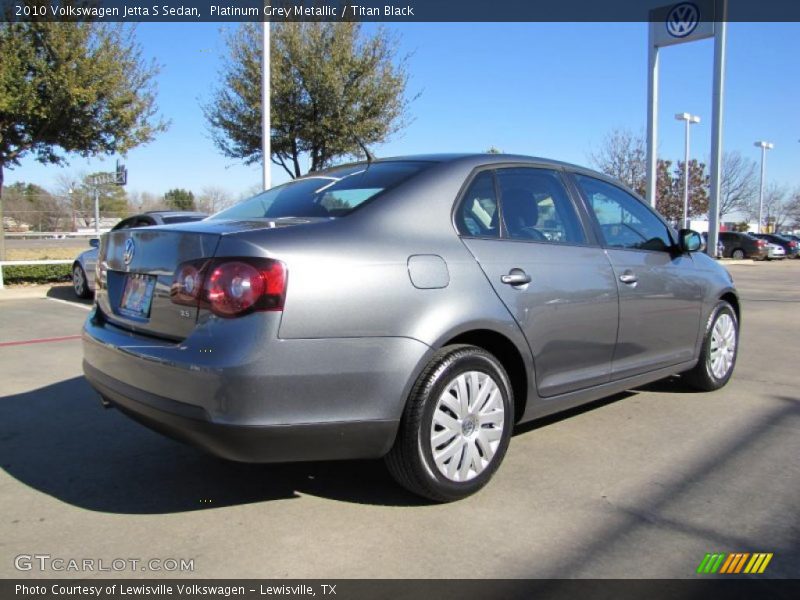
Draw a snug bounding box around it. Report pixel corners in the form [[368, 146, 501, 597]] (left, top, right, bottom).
[[210, 161, 432, 220]]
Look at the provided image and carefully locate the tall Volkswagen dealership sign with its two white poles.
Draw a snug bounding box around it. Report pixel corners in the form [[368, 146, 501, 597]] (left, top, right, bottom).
[[647, 0, 727, 256]]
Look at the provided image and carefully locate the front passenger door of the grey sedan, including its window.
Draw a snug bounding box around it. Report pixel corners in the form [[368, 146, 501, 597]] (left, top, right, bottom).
[[574, 174, 704, 379]]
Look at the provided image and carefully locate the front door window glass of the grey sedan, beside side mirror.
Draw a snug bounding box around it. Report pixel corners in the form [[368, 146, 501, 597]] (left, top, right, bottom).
[[575, 175, 672, 251]]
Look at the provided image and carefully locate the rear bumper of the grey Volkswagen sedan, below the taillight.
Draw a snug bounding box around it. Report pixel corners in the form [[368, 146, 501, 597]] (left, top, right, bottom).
[[83, 313, 431, 462]]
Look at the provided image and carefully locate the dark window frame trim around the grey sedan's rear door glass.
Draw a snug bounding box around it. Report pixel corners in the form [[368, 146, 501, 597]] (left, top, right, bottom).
[[450, 162, 602, 248]]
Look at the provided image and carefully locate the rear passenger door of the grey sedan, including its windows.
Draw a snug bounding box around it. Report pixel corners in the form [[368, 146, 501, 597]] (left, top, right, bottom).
[[456, 167, 618, 397]]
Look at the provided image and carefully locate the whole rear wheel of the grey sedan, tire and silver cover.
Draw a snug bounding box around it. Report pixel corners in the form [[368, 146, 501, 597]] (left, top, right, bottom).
[[386, 345, 514, 502]]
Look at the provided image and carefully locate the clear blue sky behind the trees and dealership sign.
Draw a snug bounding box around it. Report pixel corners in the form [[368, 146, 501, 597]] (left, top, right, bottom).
[[6, 23, 800, 202]]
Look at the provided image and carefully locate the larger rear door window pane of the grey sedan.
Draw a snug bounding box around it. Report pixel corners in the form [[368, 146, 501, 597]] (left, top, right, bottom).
[[497, 168, 586, 244]]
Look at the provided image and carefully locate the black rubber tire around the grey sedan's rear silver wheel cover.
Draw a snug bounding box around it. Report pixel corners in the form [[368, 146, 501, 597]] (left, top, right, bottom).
[[385, 345, 514, 502]]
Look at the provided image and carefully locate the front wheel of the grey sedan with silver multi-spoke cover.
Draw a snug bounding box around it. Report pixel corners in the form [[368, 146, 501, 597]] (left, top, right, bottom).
[[684, 300, 739, 392]]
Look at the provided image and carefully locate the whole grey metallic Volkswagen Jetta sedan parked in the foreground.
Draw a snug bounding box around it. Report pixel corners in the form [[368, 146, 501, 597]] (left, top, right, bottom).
[[83, 154, 740, 501]]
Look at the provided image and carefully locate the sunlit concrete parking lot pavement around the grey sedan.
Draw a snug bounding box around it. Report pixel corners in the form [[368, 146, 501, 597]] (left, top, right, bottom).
[[0, 260, 800, 578]]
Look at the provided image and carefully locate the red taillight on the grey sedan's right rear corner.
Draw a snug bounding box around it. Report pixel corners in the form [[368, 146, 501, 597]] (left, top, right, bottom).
[[170, 258, 286, 317]]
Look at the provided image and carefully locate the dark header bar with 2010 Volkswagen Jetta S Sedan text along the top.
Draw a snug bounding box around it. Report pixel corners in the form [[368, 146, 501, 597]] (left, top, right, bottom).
[[0, 0, 800, 23]]
